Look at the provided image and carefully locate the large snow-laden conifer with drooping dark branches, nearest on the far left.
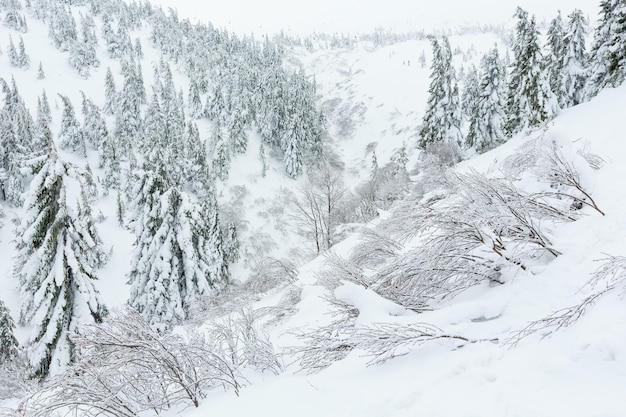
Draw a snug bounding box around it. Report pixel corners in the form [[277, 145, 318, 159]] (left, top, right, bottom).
[[15, 149, 107, 378]]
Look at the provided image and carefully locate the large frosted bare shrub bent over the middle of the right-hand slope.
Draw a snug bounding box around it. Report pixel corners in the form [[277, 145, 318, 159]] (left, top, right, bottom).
[[346, 171, 577, 310]]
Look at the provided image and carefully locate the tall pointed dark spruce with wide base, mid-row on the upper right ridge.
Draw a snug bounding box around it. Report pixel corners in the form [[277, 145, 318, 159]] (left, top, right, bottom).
[[505, 7, 558, 135]]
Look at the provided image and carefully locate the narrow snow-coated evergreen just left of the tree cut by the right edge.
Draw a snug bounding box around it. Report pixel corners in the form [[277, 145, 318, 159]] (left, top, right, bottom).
[[563, 9, 588, 107]]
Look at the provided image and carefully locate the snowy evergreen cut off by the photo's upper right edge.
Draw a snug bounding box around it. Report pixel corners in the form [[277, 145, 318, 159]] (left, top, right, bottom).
[[586, 0, 626, 98]]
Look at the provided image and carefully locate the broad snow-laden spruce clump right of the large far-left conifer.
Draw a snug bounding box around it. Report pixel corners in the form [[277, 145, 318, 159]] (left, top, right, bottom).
[[129, 149, 229, 331]]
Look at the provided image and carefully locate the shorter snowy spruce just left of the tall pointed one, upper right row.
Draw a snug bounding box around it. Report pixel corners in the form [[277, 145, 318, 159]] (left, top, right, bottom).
[[465, 47, 506, 153]]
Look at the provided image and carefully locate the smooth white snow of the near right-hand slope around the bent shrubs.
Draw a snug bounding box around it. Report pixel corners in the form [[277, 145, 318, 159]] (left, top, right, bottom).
[[189, 86, 626, 417]]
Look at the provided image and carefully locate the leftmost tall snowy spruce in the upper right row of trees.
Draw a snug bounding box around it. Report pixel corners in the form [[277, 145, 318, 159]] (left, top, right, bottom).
[[418, 37, 462, 154]]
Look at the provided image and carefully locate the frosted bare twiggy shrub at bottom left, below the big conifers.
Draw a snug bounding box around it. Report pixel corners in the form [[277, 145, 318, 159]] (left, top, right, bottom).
[[18, 311, 240, 417]]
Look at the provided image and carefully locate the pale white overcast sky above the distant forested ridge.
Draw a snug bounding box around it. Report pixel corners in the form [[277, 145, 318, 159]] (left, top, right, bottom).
[[144, 0, 597, 36]]
